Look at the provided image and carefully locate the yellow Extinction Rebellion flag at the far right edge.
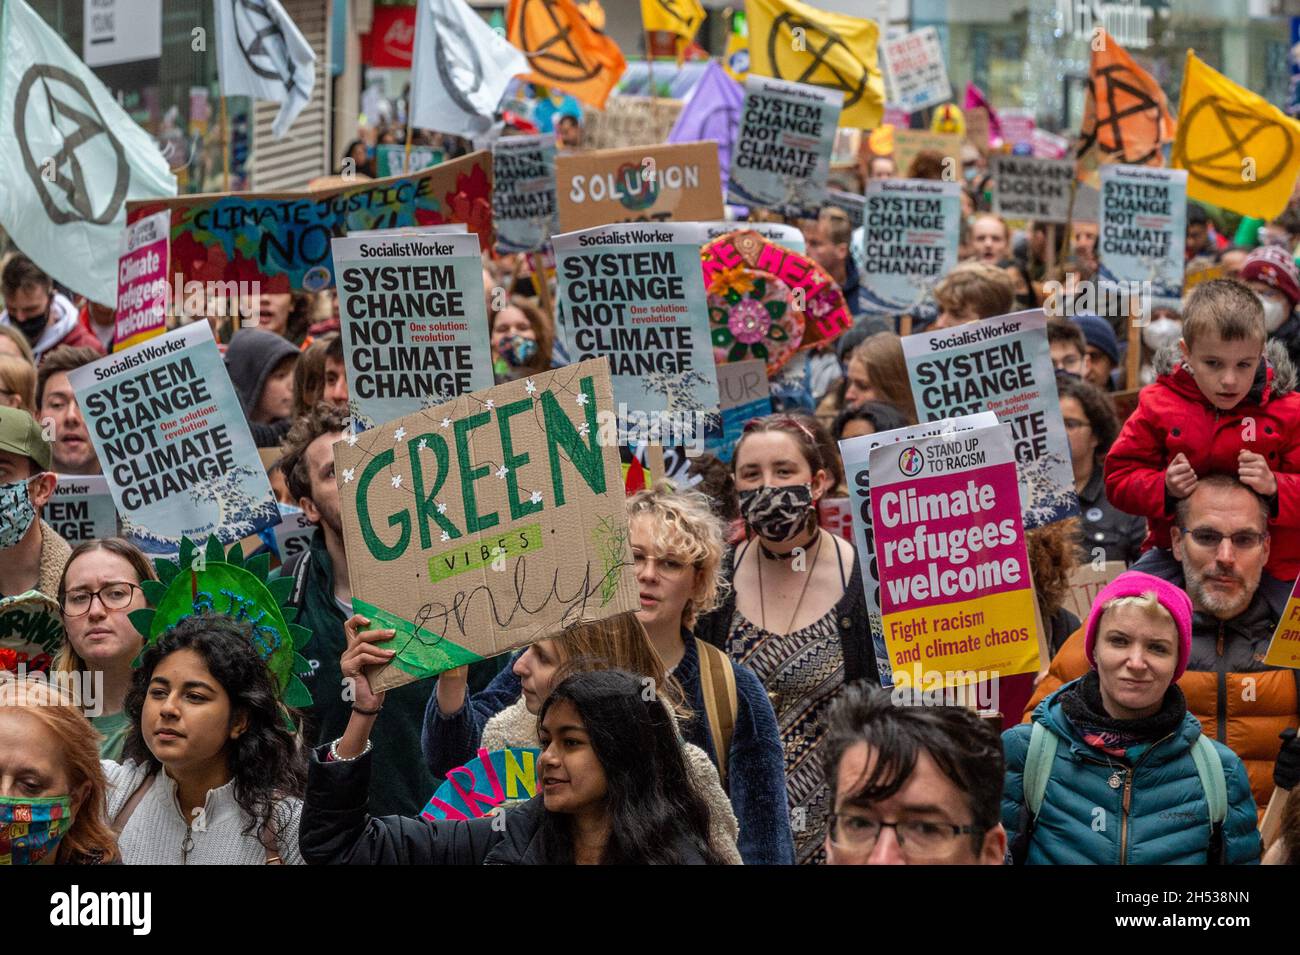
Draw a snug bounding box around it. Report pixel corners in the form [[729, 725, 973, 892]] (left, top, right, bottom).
[[1171, 51, 1300, 218]]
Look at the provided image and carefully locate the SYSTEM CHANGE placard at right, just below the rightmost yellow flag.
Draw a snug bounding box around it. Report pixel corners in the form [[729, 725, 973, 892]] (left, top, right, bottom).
[[1097, 165, 1187, 309]]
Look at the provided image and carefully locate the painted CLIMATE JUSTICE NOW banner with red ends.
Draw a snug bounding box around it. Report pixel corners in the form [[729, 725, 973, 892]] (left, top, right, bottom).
[[126, 152, 493, 296]]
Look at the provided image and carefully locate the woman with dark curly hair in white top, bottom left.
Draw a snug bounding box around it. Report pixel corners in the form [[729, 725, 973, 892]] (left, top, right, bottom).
[[104, 613, 306, 865]]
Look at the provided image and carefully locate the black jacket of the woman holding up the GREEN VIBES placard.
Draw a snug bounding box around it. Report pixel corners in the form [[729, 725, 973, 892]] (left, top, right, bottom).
[[298, 747, 705, 865]]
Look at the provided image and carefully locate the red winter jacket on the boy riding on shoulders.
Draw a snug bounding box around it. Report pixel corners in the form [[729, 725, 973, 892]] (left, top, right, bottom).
[[1105, 342, 1300, 581]]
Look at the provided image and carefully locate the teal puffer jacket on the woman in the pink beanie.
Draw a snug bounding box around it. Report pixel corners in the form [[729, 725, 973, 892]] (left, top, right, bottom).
[[1002, 681, 1260, 865]]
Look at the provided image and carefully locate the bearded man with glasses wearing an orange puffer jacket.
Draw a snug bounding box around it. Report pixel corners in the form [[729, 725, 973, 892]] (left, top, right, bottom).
[[1024, 474, 1300, 811]]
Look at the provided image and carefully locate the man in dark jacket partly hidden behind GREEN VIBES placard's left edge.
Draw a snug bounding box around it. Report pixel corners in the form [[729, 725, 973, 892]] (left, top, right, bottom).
[[278, 403, 499, 816]]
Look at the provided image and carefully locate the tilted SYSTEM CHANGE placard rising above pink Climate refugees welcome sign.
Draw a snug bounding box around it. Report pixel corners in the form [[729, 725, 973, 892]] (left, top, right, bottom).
[[902, 308, 1079, 530]]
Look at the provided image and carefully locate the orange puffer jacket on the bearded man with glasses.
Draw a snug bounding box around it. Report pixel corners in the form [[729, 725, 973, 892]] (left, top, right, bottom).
[[1023, 571, 1300, 812]]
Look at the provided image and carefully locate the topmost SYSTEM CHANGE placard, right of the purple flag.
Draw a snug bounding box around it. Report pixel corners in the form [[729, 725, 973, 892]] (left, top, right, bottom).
[[727, 74, 844, 218]]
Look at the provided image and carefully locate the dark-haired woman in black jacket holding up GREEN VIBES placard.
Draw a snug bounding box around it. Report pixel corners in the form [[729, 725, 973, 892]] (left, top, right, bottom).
[[302, 616, 720, 865]]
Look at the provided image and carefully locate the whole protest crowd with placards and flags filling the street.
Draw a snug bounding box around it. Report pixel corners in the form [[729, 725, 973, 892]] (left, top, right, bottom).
[[0, 0, 1300, 865]]
